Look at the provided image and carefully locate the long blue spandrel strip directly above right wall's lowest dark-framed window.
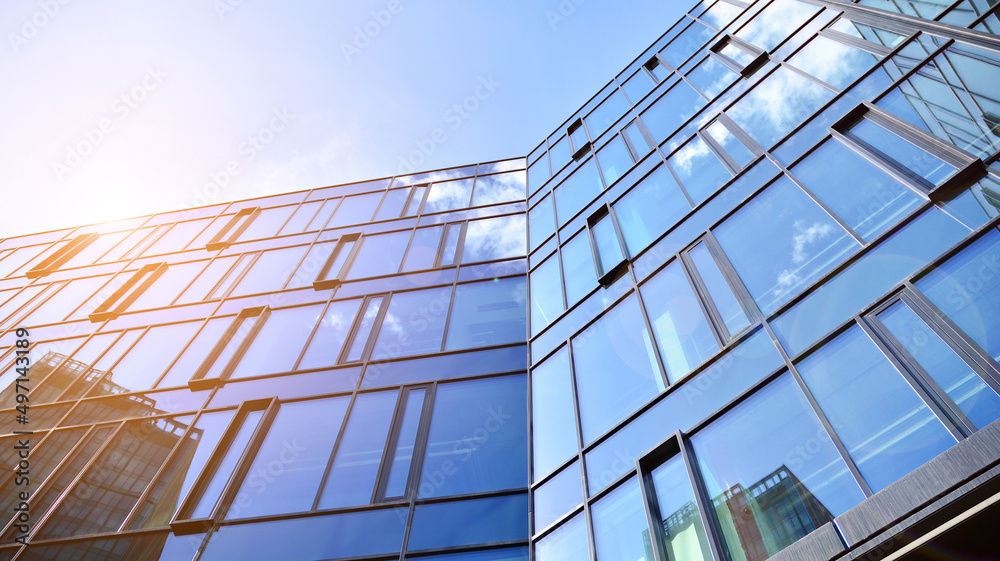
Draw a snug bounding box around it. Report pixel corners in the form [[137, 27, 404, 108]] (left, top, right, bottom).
[[586, 331, 782, 494]]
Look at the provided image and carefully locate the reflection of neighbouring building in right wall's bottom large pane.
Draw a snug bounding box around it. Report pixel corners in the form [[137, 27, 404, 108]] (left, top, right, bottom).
[[712, 466, 833, 561]]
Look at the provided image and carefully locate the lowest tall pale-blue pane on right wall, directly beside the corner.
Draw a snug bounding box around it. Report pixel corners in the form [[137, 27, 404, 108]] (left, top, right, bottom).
[[531, 347, 577, 480]]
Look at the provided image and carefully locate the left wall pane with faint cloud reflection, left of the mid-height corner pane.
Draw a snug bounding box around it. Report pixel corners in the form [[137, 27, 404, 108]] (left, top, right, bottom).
[[372, 286, 451, 359]]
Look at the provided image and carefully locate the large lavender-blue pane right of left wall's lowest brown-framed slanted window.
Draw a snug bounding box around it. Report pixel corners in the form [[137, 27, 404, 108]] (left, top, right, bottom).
[[226, 397, 350, 519]]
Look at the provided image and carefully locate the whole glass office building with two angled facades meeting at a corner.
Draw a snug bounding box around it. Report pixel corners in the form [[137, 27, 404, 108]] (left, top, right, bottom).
[[0, 0, 1000, 561]]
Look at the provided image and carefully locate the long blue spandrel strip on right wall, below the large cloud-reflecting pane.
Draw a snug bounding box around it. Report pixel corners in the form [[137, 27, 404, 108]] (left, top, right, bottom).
[[771, 207, 969, 356]]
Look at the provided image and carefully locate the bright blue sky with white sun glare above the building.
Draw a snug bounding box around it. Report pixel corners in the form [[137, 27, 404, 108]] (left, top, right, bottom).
[[0, 0, 691, 236]]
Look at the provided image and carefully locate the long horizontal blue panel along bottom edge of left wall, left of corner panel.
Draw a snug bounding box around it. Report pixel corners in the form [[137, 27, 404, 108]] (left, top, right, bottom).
[[200, 508, 407, 561]]
